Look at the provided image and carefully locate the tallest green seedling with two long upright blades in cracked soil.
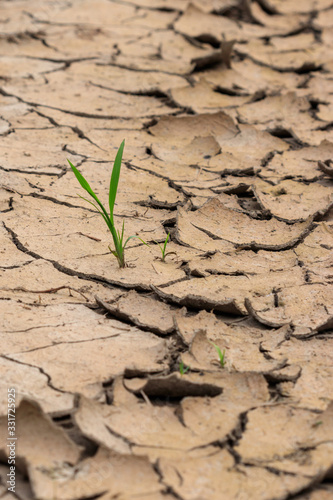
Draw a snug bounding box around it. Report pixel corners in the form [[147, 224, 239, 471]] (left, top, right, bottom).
[[67, 141, 147, 267]]
